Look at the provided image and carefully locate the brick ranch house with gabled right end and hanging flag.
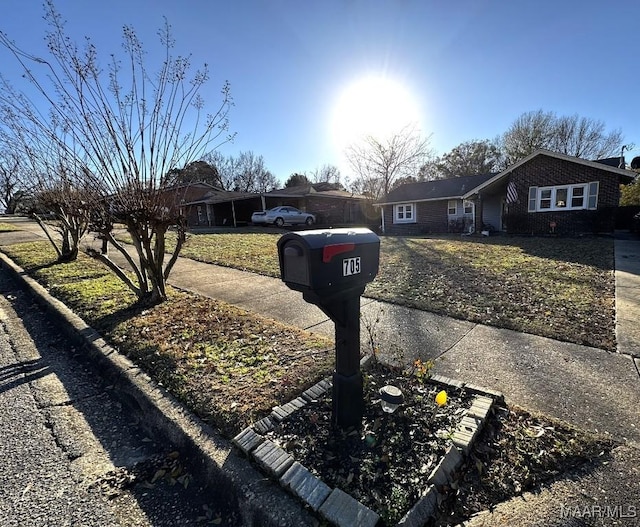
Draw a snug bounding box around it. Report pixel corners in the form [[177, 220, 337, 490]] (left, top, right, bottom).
[[376, 150, 635, 235]]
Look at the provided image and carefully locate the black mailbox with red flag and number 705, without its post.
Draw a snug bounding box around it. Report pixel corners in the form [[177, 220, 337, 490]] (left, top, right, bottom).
[[278, 228, 380, 303]]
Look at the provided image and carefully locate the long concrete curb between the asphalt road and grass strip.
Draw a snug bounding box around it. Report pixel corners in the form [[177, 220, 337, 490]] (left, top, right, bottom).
[[0, 253, 317, 527]]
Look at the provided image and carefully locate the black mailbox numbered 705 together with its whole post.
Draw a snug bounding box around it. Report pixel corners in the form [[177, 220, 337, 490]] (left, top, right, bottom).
[[278, 228, 380, 428]]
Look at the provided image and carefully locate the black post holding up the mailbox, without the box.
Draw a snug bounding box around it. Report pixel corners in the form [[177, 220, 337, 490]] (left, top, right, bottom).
[[321, 294, 364, 429]]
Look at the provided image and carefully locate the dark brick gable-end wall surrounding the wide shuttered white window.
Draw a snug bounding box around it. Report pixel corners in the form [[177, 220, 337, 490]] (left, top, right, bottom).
[[506, 155, 620, 235]]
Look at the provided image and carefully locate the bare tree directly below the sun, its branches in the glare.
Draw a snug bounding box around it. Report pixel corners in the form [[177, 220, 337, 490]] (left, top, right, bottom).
[[346, 125, 432, 198]]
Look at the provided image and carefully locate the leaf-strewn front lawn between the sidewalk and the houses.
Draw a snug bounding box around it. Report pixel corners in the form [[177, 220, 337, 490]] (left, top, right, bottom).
[[176, 233, 615, 350]]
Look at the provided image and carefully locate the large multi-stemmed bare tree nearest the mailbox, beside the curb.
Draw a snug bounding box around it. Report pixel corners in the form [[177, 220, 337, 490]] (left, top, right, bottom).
[[0, 0, 231, 302]]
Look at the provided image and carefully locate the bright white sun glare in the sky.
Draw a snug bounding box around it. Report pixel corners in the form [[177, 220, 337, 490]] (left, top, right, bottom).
[[330, 77, 420, 151]]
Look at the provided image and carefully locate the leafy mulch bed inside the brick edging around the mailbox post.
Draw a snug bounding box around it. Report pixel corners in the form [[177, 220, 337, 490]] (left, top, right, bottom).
[[268, 364, 473, 525]]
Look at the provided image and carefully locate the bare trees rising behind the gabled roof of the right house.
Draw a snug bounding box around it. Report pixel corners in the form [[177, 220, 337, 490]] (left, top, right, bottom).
[[501, 110, 624, 163]]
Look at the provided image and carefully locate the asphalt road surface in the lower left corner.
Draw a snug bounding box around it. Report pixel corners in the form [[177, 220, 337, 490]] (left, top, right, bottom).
[[0, 270, 236, 527]]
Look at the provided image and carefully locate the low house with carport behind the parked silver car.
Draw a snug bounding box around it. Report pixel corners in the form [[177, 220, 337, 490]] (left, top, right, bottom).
[[183, 183, 379, 227]]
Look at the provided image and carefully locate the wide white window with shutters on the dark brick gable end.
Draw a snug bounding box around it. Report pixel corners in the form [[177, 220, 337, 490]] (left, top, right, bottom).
[[528, 181, 598, 212]]
